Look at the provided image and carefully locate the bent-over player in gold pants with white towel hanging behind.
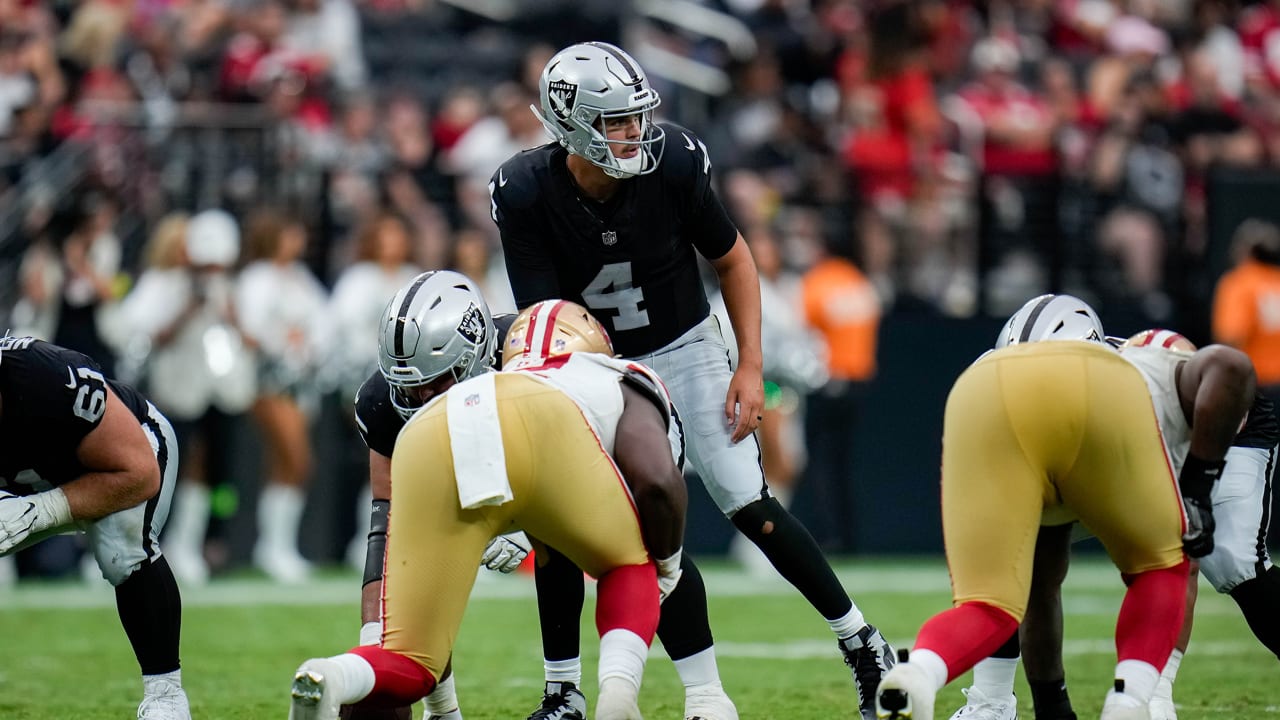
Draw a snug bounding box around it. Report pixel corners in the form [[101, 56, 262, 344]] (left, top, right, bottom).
[[289, 296, 687, 720]]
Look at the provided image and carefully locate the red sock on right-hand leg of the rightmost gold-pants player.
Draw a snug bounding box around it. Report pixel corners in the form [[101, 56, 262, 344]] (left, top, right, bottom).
[[1116, 560, 1190, 670]]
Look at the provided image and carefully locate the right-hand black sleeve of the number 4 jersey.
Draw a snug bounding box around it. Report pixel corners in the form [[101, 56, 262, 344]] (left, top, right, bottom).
[[662, 126, 737, 260]]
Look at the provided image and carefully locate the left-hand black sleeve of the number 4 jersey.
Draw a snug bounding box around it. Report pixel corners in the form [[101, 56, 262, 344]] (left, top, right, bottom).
[[489, 155, 559, 307]]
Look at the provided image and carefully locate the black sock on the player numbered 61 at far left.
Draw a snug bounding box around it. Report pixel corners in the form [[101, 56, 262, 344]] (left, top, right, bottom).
[[115, 555, 182, 675]]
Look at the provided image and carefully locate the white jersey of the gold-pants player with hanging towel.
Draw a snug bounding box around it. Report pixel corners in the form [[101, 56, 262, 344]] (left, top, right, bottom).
[[508, 352, 685, 466]]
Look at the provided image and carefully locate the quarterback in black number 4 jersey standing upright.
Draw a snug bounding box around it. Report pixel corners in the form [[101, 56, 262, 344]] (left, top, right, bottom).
[[489, 42, 893, 719]]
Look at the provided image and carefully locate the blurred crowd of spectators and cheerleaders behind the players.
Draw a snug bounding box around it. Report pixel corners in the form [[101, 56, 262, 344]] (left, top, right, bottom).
[[0, 0, 1280, 579]]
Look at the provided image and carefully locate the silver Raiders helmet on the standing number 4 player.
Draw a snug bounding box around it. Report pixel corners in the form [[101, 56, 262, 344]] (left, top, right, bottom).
[[529, 42, 666, 178]]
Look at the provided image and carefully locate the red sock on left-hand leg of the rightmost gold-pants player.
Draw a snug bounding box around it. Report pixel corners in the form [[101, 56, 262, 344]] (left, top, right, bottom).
[[915, 602, 1018, 683]]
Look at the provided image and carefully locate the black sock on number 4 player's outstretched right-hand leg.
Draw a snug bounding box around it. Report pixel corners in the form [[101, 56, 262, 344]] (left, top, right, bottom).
[[732, 497, 854, 620]]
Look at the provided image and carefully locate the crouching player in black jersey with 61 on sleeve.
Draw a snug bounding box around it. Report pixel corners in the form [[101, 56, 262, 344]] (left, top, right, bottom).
[[0, 337, 191, 720]]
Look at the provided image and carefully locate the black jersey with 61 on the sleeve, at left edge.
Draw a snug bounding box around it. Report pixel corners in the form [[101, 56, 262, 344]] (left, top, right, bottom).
[[0, 337, 147, 495]]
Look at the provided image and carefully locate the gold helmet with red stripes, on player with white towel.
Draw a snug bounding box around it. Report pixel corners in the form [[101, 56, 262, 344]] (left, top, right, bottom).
[[502, 300, 613, 370]]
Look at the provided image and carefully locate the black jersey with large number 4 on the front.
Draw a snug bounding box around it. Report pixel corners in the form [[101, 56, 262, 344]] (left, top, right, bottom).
[[489, 123, 737, 357]]
